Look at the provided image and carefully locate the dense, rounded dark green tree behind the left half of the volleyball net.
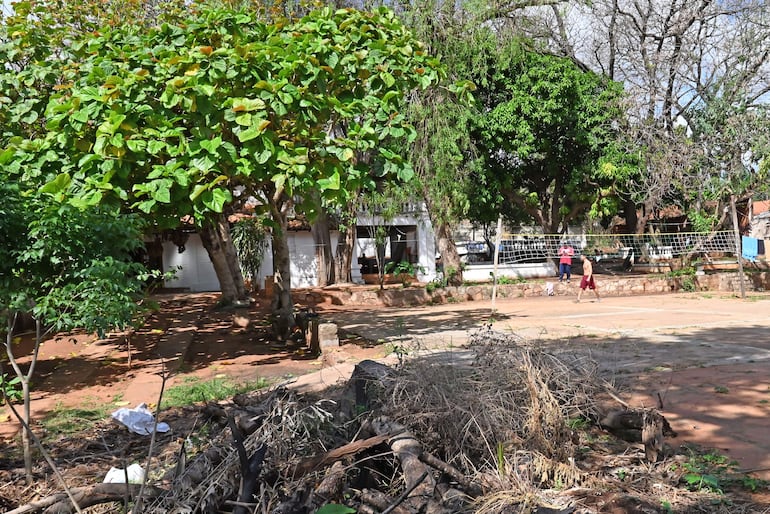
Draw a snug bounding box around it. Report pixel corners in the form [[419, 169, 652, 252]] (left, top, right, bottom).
[[468, 43, 622, 233]]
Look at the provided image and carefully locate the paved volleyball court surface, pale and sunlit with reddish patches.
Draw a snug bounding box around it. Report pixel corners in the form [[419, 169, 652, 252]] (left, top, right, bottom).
[[316, 293, 770, 479]]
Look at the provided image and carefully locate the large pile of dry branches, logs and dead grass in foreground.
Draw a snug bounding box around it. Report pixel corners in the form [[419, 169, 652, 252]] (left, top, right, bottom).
[[9, 329, 752, 514]]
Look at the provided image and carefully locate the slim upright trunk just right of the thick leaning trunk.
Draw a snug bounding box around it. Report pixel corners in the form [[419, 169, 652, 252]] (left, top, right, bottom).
[[270, 198, 294, 340]]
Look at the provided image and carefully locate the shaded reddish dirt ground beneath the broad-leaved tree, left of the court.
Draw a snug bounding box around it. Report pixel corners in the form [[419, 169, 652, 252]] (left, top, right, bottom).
[[0, 294, 383, 441]]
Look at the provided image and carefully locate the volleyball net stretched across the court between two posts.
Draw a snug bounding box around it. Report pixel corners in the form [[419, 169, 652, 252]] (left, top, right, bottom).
[[488, 231, 736, 264]]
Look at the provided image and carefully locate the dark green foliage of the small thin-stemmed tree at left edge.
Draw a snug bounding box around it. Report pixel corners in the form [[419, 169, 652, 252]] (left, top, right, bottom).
[[0, 177, 152, 335]]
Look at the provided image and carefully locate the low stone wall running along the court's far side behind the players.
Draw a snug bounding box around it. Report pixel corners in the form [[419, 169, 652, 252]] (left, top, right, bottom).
[[295, 272, 770, 307]]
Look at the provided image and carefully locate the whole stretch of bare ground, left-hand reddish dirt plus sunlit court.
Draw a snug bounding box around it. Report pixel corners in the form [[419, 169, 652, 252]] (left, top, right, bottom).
[[0, 286, 770, 505]]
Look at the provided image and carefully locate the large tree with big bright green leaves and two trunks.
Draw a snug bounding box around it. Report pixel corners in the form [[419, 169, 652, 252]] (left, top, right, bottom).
[[18, 9, 441, 330]]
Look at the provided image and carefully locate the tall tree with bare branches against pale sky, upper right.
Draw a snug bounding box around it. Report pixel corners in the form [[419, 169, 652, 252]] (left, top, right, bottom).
[[531, 0, 770, 231]]
